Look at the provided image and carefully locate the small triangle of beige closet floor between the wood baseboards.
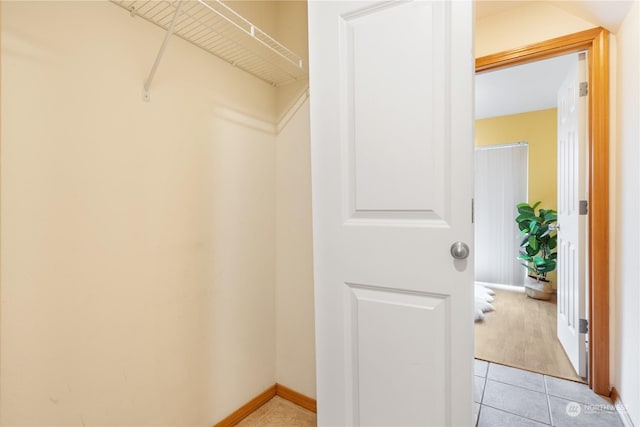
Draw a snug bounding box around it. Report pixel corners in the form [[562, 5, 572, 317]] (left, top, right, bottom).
[[237, 396, 316, 427]]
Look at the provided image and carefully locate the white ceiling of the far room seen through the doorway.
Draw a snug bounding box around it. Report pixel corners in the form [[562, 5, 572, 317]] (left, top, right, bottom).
[[476, 53, 578, 119]]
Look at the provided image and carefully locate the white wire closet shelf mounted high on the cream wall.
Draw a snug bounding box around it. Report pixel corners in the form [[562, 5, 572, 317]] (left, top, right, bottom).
[[111, 0, 306, 86]]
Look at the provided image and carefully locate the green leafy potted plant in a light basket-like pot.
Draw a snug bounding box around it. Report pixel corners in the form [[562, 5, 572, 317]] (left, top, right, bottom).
[[516, 202, 558, 300]]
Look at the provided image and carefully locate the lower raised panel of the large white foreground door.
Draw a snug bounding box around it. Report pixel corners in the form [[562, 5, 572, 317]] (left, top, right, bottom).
[[347, 284, 451, 426]]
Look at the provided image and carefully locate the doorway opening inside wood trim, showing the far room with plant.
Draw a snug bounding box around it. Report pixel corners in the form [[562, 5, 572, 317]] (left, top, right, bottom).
[[474, 52, 587, 382]]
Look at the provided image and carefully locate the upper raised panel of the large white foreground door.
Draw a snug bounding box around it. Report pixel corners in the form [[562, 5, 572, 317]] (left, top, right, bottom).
[[340, 2, 449, 224]]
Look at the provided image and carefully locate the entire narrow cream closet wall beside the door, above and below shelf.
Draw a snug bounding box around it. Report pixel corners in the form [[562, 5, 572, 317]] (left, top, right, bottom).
[[276, 1, 316, 398]]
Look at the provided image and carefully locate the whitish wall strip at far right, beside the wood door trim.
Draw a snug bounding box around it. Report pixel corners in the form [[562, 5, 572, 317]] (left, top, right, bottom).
[[612, 2, 640, 426]]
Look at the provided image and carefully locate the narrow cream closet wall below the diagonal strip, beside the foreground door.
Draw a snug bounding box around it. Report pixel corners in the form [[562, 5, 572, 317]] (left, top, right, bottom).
[[276, 100, 316, 398]]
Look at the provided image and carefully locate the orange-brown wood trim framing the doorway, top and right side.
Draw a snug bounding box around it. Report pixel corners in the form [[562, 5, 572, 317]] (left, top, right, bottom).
[[476, 27, 610, 396]]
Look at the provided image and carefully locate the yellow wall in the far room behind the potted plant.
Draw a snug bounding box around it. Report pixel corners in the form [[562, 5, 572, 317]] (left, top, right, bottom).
[[476, 108, 557, 209]]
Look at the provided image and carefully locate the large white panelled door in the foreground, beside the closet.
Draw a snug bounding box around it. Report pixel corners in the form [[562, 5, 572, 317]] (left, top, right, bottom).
[[309, 1, 474, 426]]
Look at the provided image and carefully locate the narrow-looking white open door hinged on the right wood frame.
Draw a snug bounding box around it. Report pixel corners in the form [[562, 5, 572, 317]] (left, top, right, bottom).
[[558, 53, 588, 377]]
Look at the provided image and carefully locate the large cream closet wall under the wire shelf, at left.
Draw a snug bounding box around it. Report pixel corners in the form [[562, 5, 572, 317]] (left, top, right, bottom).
[[0, 1, 276, 426]]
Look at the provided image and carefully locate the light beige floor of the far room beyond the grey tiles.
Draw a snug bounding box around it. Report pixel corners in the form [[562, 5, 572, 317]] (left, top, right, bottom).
[[475, 290, 583, 382]]
